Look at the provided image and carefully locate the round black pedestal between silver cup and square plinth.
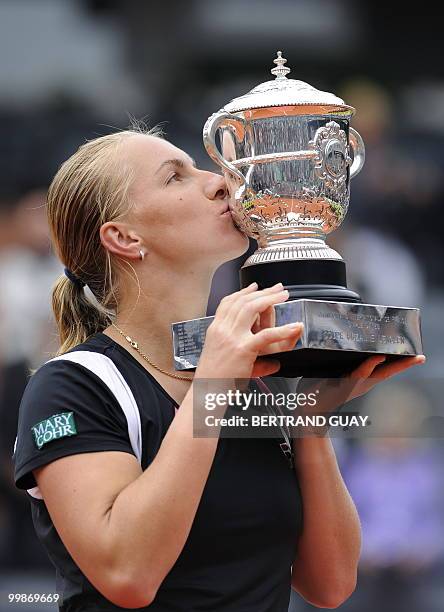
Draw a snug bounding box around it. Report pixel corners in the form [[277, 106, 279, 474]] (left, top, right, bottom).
[[240, 259, 361, 302]]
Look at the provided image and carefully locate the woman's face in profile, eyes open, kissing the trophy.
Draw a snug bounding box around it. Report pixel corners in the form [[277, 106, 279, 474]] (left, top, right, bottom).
[[123, 134, 249, 267]]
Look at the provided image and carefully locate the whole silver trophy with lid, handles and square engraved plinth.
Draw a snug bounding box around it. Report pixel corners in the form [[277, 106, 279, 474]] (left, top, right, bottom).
[[172, 51, 422, 376]]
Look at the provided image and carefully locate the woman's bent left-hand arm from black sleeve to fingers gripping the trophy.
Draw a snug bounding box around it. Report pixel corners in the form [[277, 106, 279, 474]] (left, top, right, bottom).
[[34, 286, 301, 608]]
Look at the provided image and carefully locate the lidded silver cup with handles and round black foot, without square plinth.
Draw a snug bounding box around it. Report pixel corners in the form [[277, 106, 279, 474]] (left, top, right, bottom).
[[203, 51, 365, 301]]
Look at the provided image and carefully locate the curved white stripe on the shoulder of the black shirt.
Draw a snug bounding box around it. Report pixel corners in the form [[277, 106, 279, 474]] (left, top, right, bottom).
[[23, 351, 142, 499]]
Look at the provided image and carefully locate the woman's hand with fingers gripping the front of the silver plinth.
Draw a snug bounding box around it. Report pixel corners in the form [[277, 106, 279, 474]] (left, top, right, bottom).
[[196, 283, 302, 379]]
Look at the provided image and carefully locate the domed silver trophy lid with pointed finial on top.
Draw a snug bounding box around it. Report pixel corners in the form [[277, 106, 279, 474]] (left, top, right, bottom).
[[223, 51, 355, 116]]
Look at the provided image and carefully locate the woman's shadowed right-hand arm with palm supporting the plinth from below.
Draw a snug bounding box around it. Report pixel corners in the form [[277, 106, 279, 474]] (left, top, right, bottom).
[[292, 355, 425, 608]]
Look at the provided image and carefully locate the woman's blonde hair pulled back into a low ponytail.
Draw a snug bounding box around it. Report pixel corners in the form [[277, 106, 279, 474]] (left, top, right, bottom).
[[47, 125, 162, 355]]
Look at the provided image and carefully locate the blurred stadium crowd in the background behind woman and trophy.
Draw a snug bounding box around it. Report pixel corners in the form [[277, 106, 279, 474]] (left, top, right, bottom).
[[0, 0, 444, 612]]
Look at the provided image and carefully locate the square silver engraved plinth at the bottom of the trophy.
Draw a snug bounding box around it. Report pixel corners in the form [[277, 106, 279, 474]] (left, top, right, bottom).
[[172, 299, 422, 378]]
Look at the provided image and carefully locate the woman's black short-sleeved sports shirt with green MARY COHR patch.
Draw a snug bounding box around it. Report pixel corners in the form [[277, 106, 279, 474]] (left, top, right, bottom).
[[13, 333, 302, 612]]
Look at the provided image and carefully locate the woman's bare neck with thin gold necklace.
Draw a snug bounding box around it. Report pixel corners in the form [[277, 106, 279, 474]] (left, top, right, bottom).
[[110, 270, 213, 372]]
